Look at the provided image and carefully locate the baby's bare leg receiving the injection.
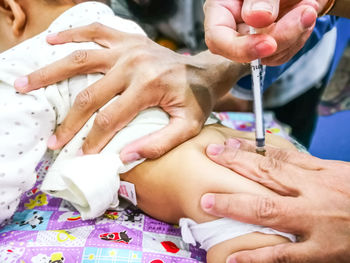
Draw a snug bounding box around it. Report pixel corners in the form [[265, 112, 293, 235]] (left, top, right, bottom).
[[121, 125, 293, 263]]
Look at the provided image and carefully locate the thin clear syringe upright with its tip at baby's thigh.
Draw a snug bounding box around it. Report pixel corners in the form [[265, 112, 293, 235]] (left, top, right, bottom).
[[250, 27, 265, 156]]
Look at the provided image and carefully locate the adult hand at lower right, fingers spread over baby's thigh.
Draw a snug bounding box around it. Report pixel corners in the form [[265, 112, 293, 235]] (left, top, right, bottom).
[[201, 139, 350, 263]]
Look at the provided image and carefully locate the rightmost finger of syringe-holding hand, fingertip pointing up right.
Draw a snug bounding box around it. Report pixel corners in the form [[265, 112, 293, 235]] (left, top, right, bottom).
[[262, 5, 317, 66]]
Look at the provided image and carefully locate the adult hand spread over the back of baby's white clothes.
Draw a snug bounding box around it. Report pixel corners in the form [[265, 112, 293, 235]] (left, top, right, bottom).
[[15, 23, 247, 162]]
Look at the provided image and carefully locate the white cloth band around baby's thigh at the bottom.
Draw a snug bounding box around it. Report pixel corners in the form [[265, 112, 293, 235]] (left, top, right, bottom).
[[179, 218, 296, 251]]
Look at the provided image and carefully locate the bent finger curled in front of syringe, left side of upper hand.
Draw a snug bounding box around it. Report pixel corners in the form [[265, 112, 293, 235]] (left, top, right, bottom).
[[205, 0, 277, 62]]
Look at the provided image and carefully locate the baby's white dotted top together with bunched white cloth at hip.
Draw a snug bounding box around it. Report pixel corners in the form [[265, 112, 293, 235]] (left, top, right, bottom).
[[0, 2, 168, 223]]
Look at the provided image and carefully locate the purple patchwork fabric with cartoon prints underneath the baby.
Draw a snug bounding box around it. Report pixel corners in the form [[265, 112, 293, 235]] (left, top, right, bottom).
[[0, 113, 285, 263]]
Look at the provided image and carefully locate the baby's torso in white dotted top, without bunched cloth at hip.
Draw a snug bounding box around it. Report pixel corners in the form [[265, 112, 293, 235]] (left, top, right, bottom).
[[0, 2, 148, 223]]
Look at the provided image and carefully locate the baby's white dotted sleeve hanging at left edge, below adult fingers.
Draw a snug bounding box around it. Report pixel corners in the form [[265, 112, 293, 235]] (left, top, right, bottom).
[[0, 87, 55, 225]]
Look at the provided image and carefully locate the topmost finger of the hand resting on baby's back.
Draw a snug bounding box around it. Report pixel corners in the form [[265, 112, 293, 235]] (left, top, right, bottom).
[[46, 22, 125, 48]]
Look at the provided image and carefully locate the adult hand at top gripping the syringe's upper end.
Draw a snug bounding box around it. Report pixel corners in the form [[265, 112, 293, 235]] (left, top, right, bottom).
[[204, 0, 327, 66]]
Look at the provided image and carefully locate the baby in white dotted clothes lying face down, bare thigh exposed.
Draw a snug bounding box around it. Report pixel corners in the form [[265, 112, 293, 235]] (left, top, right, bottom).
[[0, 0, 294, 263]]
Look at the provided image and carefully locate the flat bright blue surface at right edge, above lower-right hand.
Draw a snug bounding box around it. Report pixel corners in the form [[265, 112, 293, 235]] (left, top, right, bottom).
[[309, 111, 350, 161]]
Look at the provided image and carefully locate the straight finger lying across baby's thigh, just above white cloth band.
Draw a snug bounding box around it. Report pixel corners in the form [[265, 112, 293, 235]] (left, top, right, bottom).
[[201, 193, 304, 234]]
